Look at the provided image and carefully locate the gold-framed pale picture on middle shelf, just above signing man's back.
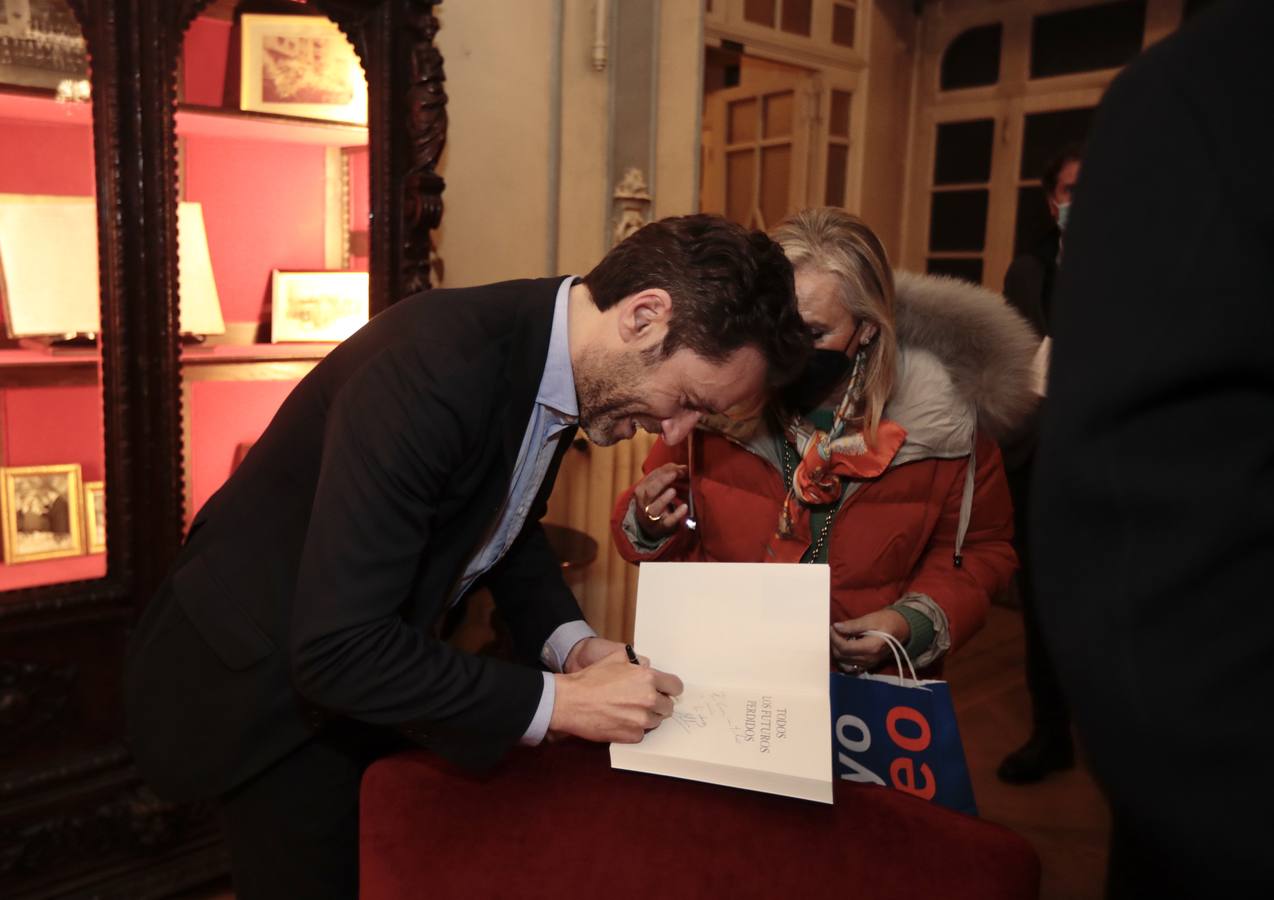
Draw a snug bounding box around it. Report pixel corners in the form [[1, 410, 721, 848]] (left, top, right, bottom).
[[270, 269, 371, 344]]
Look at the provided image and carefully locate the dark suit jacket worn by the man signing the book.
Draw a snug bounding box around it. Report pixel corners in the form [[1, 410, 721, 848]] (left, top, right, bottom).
[[126, 279, 582, 799]]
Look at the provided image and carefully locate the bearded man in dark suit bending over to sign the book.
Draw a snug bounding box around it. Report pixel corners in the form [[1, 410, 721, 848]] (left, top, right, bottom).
[[126, 215, 808, 900]]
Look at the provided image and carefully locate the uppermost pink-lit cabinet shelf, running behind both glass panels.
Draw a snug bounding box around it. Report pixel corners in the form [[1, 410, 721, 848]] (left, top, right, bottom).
[[0, 88, 367, 147]]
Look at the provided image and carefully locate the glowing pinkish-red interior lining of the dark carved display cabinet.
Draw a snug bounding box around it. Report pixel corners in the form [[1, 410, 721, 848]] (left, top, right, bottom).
[[0, 12, 369, 588]]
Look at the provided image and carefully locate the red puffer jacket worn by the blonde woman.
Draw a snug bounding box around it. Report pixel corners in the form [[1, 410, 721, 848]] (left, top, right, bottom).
[[612, 423, 1017, 649]]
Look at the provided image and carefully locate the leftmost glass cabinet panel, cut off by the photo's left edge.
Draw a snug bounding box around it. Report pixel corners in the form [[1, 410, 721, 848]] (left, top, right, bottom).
[[0, 0, 108, 588]]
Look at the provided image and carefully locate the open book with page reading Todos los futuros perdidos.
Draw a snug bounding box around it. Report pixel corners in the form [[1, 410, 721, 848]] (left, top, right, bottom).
[[610, 562, 832, 803]]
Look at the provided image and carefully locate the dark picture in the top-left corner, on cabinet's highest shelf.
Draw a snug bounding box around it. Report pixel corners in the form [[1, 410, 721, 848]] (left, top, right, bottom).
[[0, 0, 88, 88]]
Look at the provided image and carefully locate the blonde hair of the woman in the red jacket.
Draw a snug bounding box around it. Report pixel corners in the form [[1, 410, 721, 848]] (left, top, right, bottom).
[[772, 207, 898, 446]]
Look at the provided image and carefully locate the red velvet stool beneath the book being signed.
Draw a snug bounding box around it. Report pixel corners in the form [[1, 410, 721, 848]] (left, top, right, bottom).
[[361, 741, 1040, 900]]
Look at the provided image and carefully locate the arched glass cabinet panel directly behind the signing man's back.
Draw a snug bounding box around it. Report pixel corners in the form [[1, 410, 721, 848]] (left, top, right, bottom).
[[177, 3, 371, 525]]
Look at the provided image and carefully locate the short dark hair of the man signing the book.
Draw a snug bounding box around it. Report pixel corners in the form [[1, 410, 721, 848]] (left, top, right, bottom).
[[583, 215, 809, 386]]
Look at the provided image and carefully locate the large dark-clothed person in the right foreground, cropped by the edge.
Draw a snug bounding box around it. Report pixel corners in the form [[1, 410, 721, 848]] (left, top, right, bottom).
[[1034, 0, 1274, 897]]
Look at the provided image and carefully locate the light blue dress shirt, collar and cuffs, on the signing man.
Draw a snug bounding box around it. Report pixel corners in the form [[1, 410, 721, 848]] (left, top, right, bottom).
[[451, 277, 598, 744]]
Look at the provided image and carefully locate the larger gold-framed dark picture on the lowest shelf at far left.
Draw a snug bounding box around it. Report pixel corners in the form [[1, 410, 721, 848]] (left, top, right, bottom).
[[0, 463, 84, 565]]
